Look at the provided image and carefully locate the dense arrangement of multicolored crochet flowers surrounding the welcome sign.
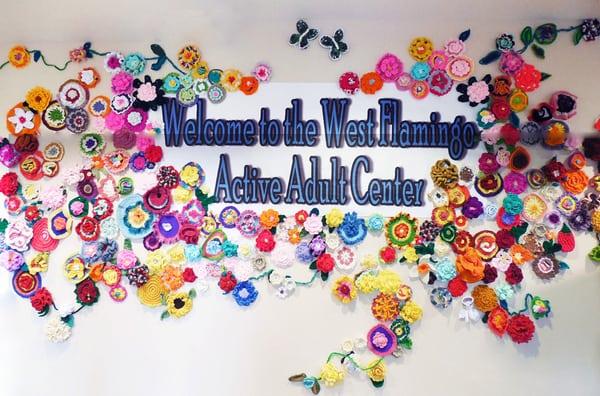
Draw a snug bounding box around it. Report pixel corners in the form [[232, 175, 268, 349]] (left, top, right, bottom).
[[0, 18, 600, 394]]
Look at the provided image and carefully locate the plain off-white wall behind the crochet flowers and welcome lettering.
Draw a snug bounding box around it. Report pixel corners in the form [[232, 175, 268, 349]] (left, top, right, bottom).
[[0, 0, 600, 396]]
